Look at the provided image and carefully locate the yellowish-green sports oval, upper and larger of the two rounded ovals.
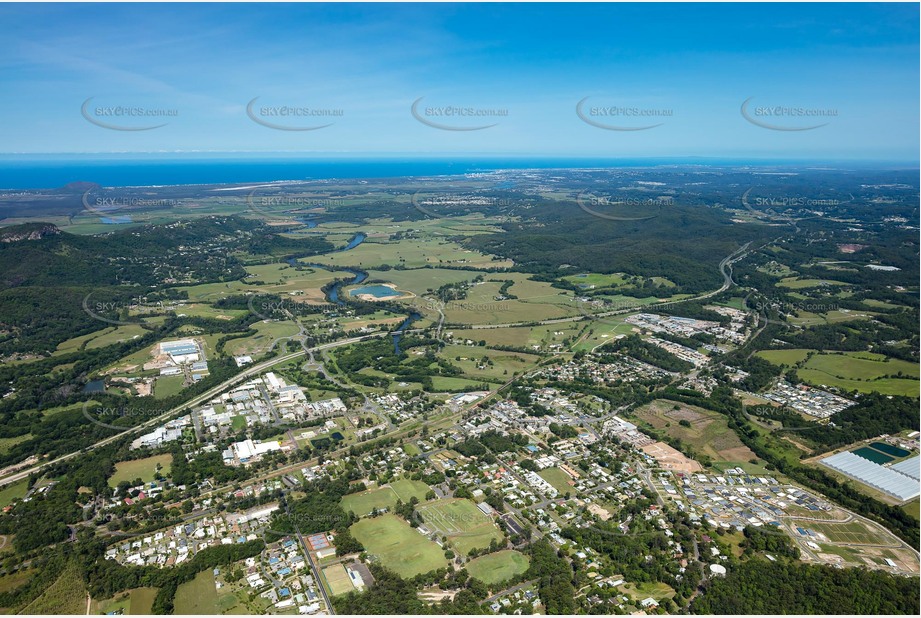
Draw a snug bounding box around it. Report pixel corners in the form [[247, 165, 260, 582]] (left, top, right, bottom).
[[418, 498, 503, 556]]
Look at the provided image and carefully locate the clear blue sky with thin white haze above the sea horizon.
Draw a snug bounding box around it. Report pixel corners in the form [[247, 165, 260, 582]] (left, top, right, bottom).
[[0, 4, 919, 161]]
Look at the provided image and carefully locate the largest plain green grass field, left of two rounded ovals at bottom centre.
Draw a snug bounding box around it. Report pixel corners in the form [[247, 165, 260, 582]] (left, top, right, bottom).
[[349, 513, 448, 578]]
